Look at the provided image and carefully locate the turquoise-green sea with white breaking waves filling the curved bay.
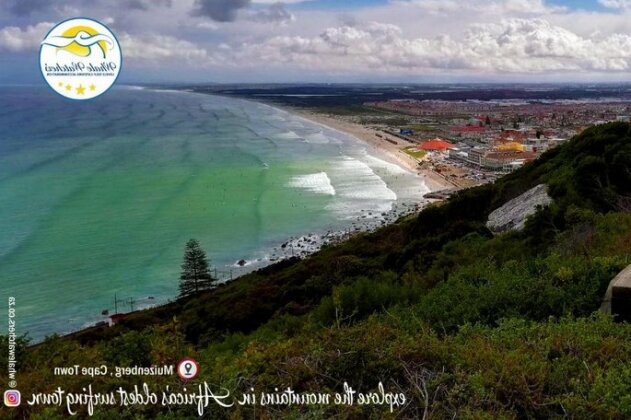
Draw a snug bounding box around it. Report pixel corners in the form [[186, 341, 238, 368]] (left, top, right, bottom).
[[0, 87, 427, 339]]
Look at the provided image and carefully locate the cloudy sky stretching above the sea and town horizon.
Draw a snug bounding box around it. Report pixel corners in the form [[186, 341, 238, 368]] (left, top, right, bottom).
[[0, 0, 631, 83]]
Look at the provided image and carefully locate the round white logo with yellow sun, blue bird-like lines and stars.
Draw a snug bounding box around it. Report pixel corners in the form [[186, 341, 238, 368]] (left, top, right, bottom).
[[39, 18, 123, 100]]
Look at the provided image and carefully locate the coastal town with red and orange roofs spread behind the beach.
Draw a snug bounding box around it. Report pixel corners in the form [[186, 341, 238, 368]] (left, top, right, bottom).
[[370, 98, 631, 179]]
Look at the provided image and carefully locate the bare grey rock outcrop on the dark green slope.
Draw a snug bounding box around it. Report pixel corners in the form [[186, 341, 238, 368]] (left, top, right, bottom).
[[486, 184, 552, 233]]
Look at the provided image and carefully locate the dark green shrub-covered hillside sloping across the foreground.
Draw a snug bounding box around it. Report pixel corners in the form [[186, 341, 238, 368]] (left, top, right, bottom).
[[1, 123, 631, 419]]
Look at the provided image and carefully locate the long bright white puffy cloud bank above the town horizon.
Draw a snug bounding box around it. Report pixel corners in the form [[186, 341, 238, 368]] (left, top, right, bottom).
[[216, 19, 631, 74]]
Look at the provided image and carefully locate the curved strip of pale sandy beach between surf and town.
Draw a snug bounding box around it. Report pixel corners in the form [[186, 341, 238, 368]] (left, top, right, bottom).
[[286, 108, 455, 191]]
